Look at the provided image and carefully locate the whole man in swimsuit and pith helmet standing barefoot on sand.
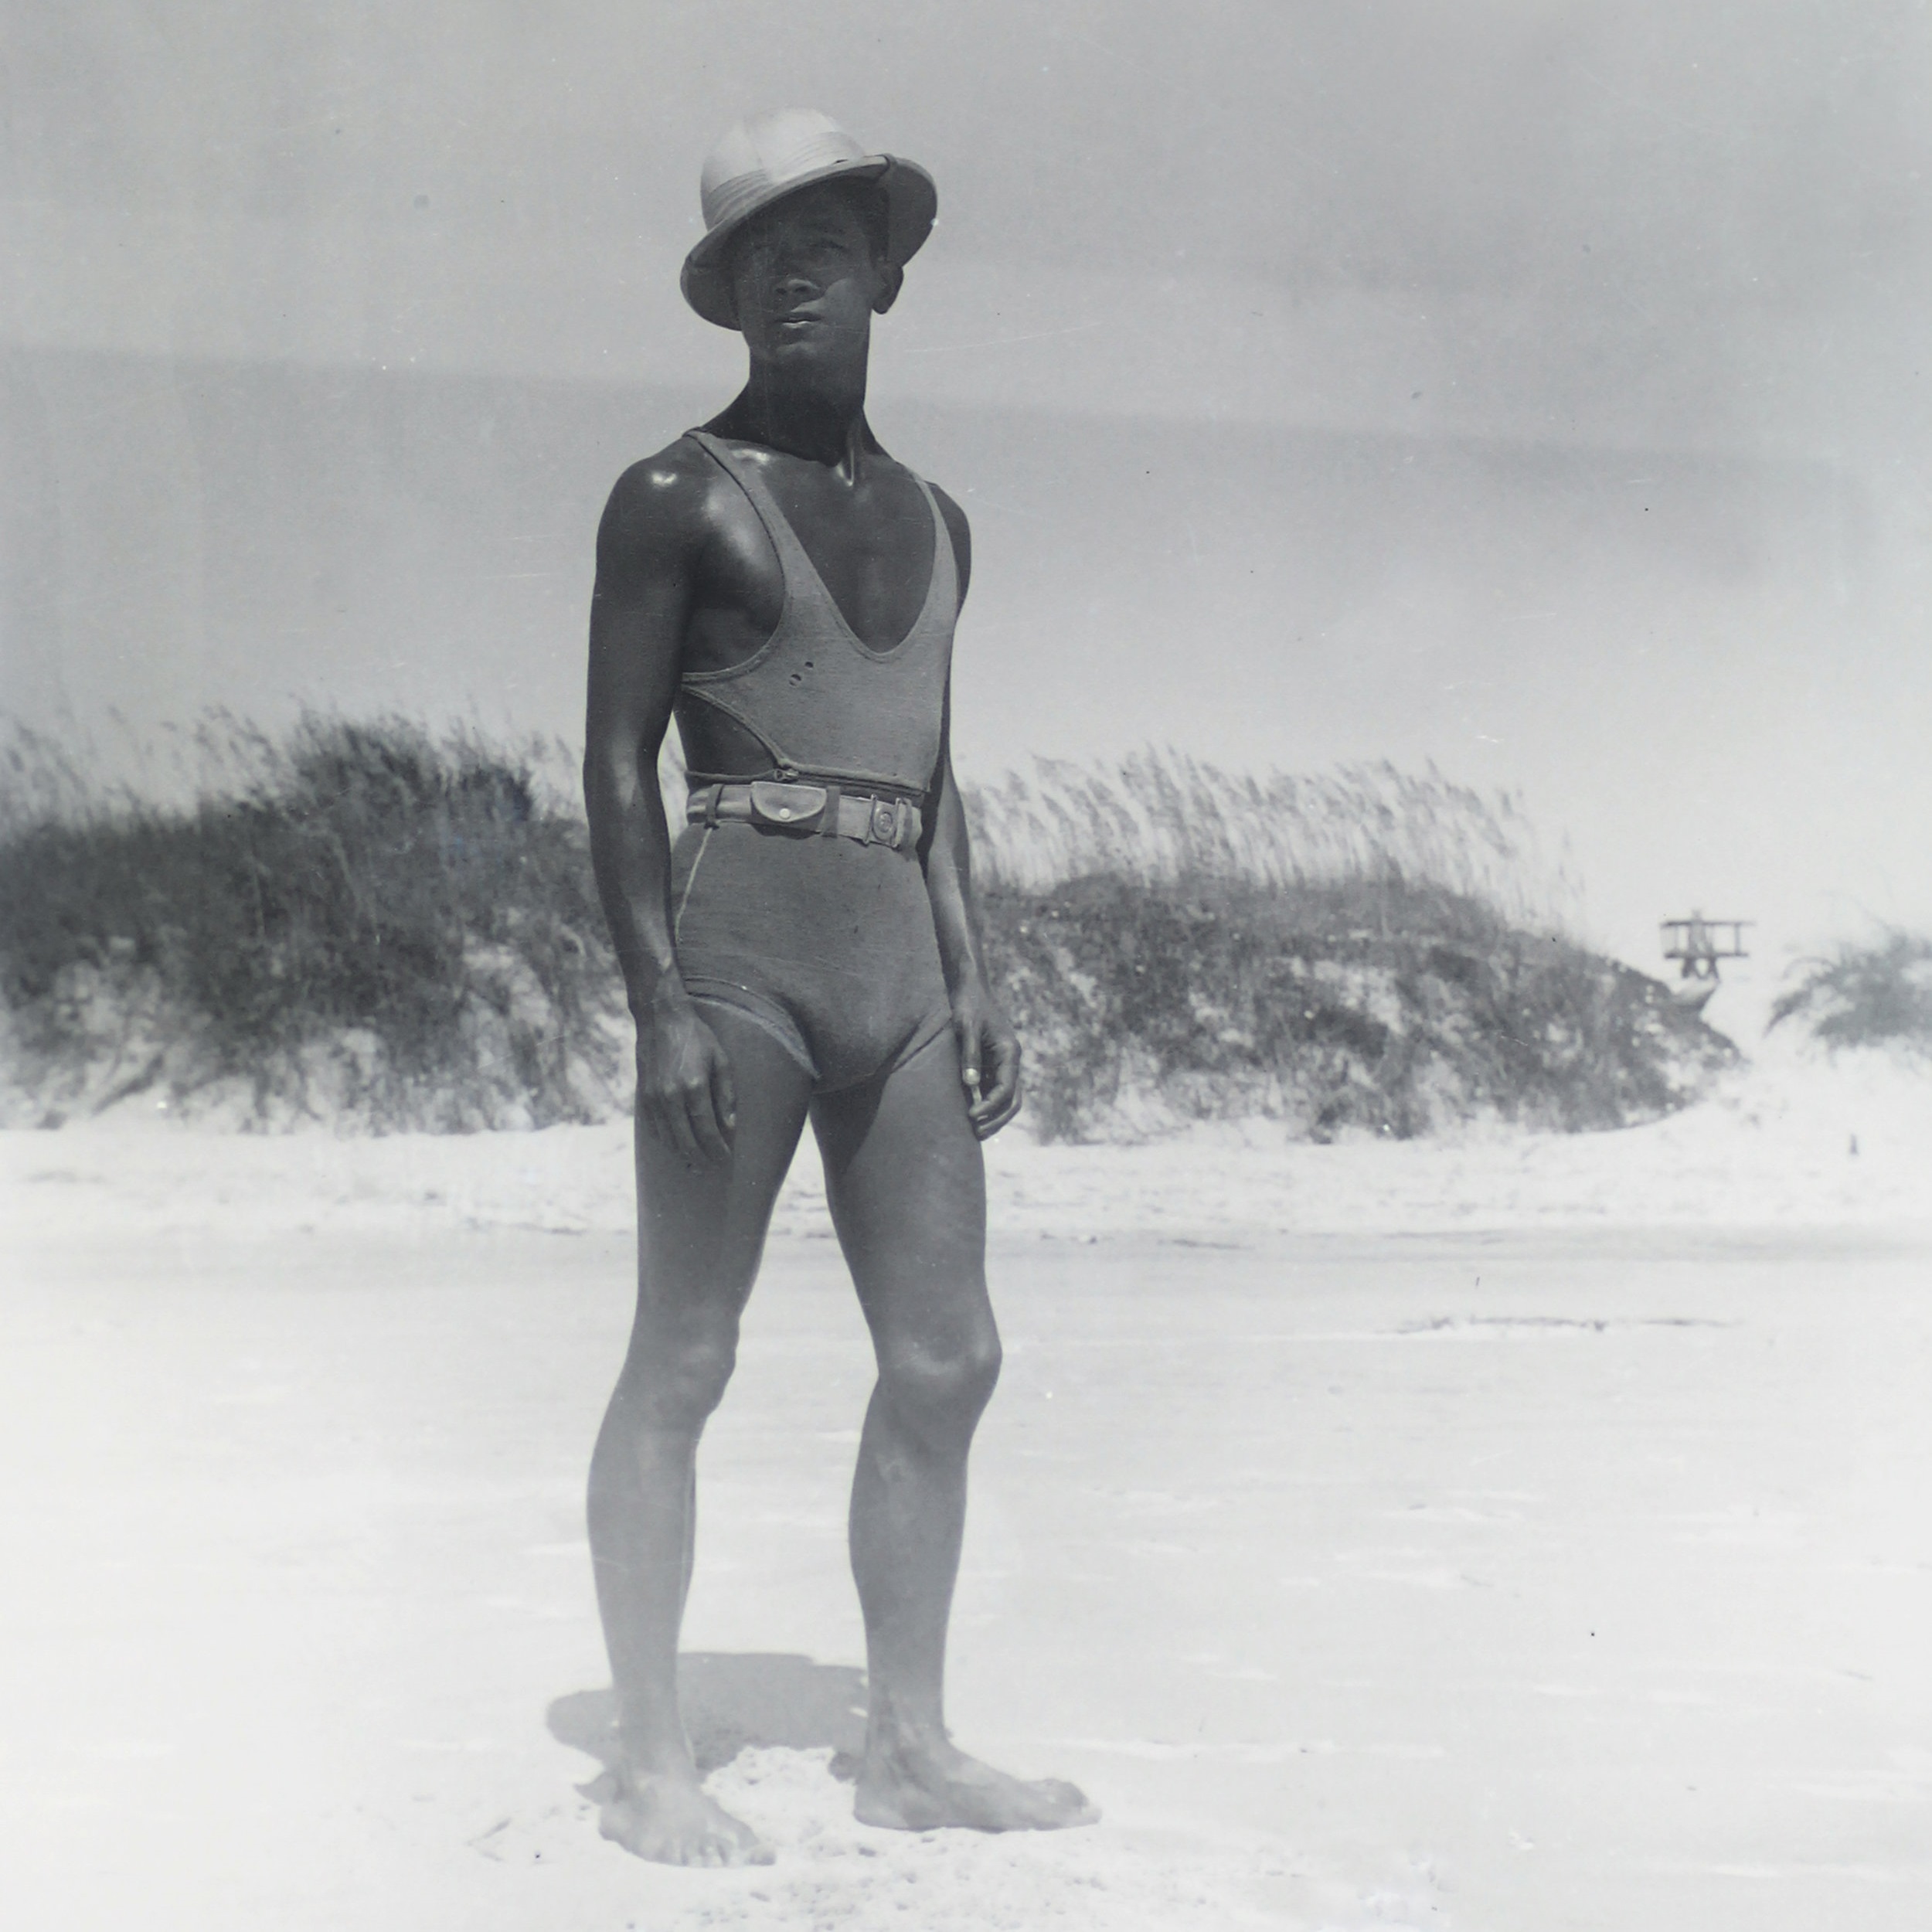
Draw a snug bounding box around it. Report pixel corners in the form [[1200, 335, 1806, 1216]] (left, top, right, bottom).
[[586, 111, 1094, 1865]]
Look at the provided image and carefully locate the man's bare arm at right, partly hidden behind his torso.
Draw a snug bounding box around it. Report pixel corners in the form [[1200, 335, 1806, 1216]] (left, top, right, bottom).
[[922, 491, 1020, 1140]]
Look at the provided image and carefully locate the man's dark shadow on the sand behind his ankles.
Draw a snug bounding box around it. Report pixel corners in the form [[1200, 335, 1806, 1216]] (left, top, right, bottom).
[[545, 1650, 866, 1781]]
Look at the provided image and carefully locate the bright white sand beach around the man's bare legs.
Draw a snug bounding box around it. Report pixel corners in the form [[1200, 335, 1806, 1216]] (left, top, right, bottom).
[[0, 1049, 1932, 1932]]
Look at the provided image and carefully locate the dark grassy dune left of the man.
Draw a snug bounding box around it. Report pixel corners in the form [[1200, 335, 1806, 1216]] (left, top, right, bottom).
[[0, 713, 614, 1127]]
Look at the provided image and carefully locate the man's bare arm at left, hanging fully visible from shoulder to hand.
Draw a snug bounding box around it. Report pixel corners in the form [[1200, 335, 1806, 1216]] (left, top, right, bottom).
[[583, 451, 736, 1159]]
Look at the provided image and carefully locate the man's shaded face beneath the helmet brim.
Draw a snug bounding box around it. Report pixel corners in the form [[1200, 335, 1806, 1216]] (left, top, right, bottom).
[[730, 184, 899, 366]]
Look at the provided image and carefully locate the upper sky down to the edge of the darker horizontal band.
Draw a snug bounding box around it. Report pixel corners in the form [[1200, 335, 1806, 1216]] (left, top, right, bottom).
[[4, 0, 1932, 452]]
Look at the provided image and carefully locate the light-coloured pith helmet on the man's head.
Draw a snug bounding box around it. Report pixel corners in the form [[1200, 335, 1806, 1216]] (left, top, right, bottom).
[[680, 108, 939, 328]]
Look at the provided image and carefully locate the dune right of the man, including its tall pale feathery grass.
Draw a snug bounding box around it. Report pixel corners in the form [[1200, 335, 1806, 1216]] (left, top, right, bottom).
[[974, 752, 1733, 1140]]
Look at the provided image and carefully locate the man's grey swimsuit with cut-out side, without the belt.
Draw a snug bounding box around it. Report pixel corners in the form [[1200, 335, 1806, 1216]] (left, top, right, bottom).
[[671, 429, 958, 1094]]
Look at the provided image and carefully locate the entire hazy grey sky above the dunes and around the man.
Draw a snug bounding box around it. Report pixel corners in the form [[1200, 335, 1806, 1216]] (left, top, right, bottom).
[[0, 0, 1932, 981]]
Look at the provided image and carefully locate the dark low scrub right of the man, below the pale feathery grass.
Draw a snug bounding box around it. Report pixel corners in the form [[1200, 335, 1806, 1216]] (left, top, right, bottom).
[[985, 877, 1735, 1140]]
